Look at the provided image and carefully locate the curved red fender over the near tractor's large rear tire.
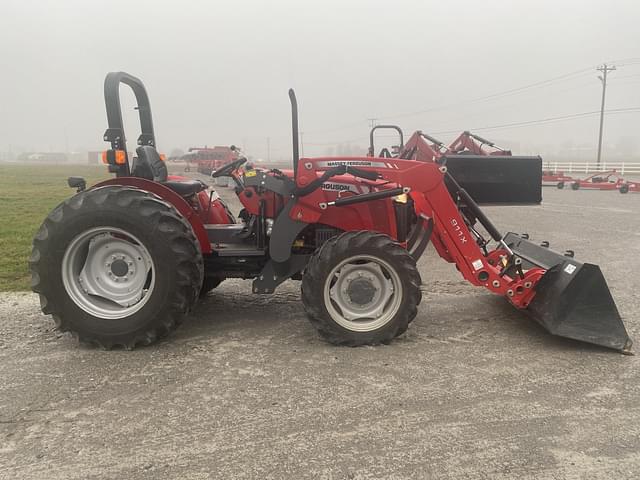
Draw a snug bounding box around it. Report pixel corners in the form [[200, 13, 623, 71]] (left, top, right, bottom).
[[91, 177, 211, 254]]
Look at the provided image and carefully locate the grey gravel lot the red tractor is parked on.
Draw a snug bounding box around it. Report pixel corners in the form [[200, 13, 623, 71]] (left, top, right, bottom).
[[0, 182, 640, 479]]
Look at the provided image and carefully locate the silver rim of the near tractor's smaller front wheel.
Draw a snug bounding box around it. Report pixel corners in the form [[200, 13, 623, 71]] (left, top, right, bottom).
[[323, 255, 402, 332]]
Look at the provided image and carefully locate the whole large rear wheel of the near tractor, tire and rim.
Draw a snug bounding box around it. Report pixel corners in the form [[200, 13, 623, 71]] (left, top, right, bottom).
[[29, 186, 203, 349]]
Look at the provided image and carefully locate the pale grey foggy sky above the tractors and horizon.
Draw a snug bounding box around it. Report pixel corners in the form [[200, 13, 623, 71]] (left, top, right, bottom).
[[0, 0, 640, 162]]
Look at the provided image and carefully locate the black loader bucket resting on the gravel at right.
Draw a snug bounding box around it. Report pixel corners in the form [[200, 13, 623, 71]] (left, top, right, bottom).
[[505, 233, 632, 353]]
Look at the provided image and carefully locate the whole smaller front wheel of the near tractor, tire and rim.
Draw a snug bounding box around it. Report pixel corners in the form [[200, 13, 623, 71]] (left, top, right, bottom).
[[302, 231, 422, 346]]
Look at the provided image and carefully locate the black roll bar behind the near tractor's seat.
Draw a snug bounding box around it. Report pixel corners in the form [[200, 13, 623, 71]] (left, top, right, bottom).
[[103, 72, 156, 176]]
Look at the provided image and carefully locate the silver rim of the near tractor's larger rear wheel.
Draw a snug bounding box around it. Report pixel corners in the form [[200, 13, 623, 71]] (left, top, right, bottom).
[[62, 227, 155, 320]]
